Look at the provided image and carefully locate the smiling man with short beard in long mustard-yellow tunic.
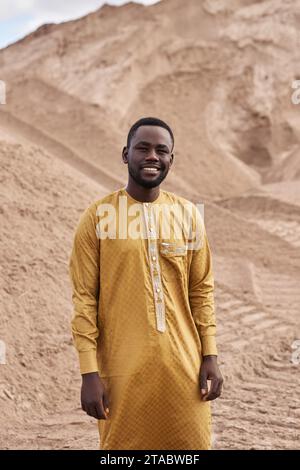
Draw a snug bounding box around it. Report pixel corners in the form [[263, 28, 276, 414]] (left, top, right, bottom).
[[70, 118, 223, 450]]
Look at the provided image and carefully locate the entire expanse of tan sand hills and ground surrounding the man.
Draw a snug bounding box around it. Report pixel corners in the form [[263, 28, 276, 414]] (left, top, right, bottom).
[[0, 0, 300, 449]]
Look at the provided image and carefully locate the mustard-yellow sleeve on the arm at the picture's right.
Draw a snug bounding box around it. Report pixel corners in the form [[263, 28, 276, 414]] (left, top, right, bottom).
[[189, 211, 217, 356]]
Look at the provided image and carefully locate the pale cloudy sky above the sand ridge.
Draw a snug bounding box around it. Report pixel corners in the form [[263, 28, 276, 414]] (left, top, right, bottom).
[[0, 0, 158, 49]]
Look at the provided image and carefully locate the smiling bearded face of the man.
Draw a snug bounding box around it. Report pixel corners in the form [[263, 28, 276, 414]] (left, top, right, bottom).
[[123, 126, 173, 188]]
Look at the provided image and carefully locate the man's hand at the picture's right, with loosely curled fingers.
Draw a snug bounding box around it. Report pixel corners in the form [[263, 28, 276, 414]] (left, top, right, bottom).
[[200, 356, 223, 401]]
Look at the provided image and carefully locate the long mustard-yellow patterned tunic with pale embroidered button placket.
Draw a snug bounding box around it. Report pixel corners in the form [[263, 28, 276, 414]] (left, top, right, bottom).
[[70, 188, 217, 450]]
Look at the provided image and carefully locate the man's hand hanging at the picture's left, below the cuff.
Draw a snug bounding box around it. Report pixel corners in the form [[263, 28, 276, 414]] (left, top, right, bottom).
[[81, 372, 109, 419]]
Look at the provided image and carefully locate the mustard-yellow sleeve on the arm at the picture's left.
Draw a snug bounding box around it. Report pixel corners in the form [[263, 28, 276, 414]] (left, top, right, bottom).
[[69, 208, 99, 374]]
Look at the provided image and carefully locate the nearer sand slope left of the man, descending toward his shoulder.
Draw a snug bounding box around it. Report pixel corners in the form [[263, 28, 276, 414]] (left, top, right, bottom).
[[0, 141, 108, 448]]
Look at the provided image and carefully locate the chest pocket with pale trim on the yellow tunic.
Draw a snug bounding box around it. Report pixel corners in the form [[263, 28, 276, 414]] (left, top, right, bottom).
[[159, 241, 187, 282]]
